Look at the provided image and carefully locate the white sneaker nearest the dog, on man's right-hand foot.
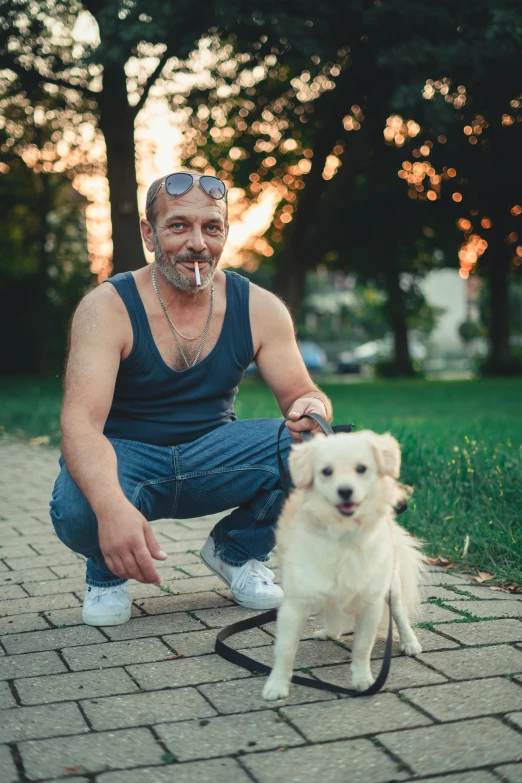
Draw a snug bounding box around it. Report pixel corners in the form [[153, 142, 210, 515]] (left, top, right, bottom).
[[199, 536, 283, 609]]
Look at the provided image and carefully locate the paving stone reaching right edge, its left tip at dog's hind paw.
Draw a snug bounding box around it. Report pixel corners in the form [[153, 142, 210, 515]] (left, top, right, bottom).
[[422, 644, 522, 680]]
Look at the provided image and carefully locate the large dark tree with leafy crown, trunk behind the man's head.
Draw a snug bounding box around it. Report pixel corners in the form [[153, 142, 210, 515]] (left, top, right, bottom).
[[0, 0, 320, 272]]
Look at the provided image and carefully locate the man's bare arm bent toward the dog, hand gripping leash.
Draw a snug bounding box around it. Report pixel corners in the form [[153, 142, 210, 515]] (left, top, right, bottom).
[[250, 286, 332, 440]]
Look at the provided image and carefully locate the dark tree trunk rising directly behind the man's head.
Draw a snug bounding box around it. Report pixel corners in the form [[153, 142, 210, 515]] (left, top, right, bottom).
[[98, 63, 145, 274]]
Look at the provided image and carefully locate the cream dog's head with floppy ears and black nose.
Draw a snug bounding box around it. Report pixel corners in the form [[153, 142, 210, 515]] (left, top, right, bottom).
[[288, 430, 401, 517]]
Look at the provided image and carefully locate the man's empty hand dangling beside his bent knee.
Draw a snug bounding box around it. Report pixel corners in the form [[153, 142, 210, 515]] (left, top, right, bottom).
[[98, 501, 168, 585]]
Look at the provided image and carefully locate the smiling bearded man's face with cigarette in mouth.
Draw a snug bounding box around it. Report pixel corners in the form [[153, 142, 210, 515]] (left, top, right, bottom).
[[141, 175, 228, 291]]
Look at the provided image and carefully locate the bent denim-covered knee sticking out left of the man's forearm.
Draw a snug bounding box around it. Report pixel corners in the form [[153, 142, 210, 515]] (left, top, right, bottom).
[[50, 466, 98, 557]]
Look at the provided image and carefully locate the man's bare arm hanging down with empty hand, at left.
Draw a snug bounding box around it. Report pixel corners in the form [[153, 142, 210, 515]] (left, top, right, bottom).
[[61, 285, 166, 583]]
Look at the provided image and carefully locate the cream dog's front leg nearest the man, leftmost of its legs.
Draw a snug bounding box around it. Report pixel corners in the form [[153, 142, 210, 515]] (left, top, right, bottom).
[[263, 598, 308, 700]]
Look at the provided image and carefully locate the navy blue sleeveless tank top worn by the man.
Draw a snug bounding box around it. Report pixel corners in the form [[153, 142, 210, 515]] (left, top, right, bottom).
[[104, 272, 254, 446]]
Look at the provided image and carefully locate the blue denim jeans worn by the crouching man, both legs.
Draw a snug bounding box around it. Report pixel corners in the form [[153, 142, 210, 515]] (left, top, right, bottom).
[[50, 419, 292, 587]]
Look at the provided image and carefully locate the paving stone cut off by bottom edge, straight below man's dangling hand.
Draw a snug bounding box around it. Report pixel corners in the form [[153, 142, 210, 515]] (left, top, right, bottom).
[[99, 759, 252, 783]]
